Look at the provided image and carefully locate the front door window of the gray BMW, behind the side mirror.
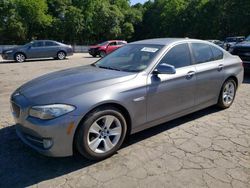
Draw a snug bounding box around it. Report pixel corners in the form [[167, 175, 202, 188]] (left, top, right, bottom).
[[159, 44, 192, 68]]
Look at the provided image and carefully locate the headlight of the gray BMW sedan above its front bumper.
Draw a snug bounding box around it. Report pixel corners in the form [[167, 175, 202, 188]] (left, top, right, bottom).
[[29, 104, 75, 120]]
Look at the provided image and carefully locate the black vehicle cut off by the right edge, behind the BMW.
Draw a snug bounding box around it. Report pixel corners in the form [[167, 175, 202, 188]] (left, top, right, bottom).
[[229, 35, 250, 72]]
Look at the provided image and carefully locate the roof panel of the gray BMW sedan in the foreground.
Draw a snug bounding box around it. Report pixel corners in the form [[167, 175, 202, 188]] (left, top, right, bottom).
[[130, 38, 206, 46]]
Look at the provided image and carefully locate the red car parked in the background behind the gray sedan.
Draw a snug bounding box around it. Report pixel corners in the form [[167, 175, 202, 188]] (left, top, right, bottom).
[[89, 40, 127, 57]]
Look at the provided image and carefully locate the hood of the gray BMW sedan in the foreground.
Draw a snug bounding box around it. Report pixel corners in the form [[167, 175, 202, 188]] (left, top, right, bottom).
[[17, 65, 136, 102]]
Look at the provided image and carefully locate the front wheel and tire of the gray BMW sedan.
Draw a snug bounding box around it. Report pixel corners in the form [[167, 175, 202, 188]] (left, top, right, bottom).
[[75, 107, 127, 161]]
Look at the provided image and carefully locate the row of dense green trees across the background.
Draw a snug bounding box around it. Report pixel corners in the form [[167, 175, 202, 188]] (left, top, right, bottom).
[[0, 0, 250, 44]]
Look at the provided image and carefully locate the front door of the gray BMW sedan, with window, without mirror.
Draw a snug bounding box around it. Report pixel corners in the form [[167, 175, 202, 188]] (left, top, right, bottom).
[[147, 43, 196, 121]]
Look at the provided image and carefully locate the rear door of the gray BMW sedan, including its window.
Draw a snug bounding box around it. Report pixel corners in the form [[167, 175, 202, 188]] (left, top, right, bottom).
[[191, 42, 224, 105]]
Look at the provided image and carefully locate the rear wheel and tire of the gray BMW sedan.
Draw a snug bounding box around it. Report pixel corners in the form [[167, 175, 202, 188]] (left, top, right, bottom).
[[217, 78, 237, 109]]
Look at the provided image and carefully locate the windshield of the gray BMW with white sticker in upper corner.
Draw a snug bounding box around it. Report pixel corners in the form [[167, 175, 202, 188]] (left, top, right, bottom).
[[93, 44, 163, 72]]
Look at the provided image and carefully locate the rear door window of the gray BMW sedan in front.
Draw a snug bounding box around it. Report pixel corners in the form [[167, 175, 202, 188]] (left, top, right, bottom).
[[192, 43, 214, 64]]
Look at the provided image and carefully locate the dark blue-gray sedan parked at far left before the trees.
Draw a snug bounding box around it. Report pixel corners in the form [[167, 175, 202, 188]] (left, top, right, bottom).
[[2, 40, 73, 63]]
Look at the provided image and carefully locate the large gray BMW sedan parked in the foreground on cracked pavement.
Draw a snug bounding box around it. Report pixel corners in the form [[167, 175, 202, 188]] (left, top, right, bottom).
[[11, 38, 243, 160]]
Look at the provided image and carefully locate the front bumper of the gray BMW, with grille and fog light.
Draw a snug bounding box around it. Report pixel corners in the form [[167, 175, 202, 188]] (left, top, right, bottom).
[[12, 95, 79, 157]]
